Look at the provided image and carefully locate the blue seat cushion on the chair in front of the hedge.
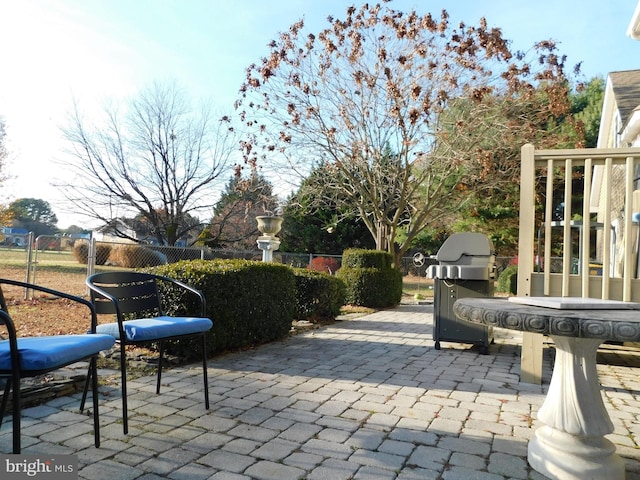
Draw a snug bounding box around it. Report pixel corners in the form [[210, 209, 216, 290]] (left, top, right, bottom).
[[96, 316, 213, 342]]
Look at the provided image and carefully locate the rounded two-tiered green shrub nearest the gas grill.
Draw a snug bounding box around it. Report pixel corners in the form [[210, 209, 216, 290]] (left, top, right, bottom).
[[336, 249, 402, 308]]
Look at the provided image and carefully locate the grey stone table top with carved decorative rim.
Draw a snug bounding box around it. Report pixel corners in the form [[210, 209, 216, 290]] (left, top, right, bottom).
[[453, 297, 640, 342]]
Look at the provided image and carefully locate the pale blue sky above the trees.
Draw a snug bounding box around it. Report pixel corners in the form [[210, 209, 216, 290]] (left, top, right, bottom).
[[0, 0, 640, 227]]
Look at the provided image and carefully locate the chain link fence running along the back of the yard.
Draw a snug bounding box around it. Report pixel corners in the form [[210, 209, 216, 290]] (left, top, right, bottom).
[[0, 234, 515, 298]]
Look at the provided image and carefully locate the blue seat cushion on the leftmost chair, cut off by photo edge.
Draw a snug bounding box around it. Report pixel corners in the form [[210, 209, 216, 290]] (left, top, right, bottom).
[[0, 334, 115, 373]]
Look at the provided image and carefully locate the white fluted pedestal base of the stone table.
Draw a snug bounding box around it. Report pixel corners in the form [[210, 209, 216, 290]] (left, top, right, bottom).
[[528, 335, 625, 480]]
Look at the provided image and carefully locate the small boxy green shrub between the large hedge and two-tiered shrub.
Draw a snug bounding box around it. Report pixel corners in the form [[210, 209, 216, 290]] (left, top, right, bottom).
[[293, 268, 346, 322]]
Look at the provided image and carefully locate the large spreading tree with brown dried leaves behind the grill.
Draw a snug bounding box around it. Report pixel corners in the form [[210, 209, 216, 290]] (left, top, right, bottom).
[[236, 2, 570, 259]]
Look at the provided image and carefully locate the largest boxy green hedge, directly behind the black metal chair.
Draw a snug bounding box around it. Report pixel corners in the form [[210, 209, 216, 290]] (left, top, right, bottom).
[[146, 260, 296, 357]]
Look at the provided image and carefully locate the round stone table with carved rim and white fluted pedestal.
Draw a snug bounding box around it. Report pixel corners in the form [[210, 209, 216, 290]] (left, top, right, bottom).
[[453, 297, 640, 480]]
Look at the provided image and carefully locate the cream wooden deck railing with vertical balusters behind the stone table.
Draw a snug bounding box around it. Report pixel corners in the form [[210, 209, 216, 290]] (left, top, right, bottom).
[[518, 144, 640, 383]]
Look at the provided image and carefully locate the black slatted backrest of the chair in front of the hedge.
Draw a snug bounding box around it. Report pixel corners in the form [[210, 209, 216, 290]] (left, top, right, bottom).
[[87, 272, 163, 315]]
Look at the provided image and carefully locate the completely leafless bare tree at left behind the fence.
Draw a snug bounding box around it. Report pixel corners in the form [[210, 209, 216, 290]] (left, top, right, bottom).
[[59, 84, 237, 245]]
